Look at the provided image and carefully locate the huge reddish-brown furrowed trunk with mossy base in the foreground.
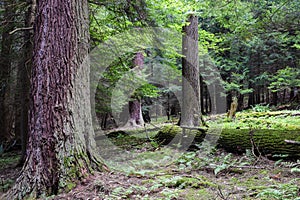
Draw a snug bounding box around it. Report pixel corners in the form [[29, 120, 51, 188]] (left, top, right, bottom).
[[4, 0, 104, 199]]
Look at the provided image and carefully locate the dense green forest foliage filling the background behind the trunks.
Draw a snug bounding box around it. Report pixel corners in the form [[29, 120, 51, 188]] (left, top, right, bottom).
[[0, 0, 300, 145]]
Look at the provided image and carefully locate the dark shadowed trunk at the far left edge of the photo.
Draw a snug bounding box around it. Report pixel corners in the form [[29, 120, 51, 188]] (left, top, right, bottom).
[[0, 0, 15, 142]]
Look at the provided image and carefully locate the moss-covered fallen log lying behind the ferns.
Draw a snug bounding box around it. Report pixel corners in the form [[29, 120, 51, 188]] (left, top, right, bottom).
[[155, 126, 300, 158]]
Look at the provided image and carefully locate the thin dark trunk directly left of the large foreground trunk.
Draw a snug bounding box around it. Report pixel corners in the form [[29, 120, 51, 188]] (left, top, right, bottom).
[[15, 0, 36, 164]]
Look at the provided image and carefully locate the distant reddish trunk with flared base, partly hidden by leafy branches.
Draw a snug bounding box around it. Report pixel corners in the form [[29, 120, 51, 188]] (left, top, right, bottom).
[[125, 52, 145, 127]]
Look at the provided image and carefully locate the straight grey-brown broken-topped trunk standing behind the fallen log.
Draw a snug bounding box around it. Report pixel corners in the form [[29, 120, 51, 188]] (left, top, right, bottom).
[[180, 15, 201, 126]]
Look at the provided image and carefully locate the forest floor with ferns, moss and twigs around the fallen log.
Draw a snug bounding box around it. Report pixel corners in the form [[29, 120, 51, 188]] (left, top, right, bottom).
[[0, 110, 300, 200]]
